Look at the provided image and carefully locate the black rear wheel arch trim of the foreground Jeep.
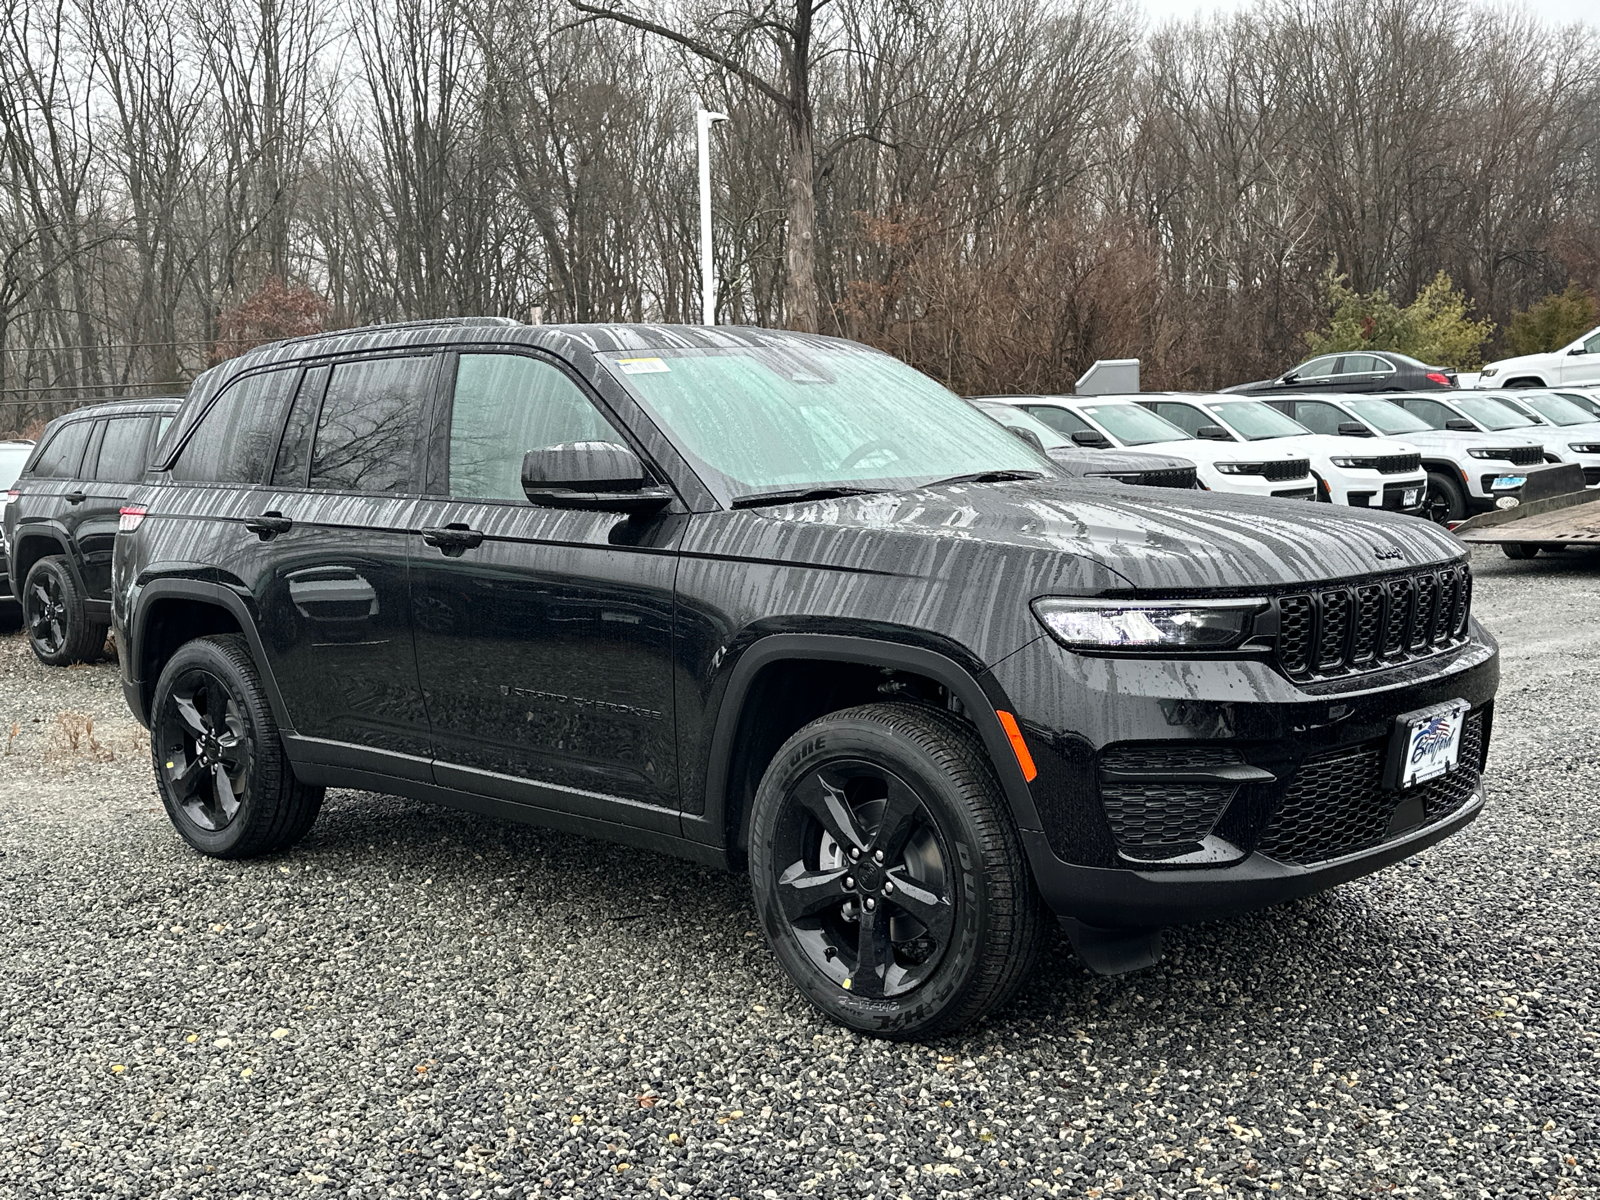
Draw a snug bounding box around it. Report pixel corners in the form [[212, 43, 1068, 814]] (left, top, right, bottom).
[[126, 579, 294, 733]]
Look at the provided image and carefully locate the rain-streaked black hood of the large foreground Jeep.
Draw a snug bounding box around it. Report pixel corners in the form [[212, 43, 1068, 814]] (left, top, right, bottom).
[[739, 480, 1462, 600]]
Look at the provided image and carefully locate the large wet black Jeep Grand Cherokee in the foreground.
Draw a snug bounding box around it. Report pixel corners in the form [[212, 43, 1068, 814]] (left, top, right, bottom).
[[114, 320, 1499, 1037]]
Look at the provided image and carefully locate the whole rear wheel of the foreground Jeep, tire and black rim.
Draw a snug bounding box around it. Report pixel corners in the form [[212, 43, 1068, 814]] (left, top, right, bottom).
[[150, 634, 323, 858]]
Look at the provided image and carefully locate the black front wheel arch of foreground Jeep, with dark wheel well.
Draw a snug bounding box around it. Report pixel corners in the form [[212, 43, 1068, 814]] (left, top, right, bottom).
[[685, 634, 1040, 862]]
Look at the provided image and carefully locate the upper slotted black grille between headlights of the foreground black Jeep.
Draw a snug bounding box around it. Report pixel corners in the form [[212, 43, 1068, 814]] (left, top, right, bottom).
[[1275, 563, 1472, 680]]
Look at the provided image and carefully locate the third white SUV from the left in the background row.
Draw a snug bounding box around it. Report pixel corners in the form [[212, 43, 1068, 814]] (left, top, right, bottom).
[[1269, 392, 1544, 525]]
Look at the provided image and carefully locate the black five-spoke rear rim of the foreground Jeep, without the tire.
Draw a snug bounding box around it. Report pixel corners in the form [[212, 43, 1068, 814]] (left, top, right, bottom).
[[155, 667, 254, 832]]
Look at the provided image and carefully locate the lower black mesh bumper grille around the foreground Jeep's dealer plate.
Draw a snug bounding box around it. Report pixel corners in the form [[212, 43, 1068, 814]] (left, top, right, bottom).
[[1256, 710, 1483, 864]]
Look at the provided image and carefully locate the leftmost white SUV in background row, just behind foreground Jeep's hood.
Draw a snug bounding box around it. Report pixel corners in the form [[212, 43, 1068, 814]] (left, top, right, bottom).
[[992, 395, 1317, 499]]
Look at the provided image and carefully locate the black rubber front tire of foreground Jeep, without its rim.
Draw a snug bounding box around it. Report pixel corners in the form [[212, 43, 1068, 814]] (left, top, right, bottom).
[[750, 704, 1051, 1040]]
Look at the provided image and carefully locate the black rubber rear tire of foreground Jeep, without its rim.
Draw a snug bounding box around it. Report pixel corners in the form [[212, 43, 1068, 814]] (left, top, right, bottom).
[[150, 634, 323, 858]]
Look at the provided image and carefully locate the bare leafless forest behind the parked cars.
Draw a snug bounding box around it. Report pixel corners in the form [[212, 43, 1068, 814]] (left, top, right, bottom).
[[0, 0, 1600, 429]]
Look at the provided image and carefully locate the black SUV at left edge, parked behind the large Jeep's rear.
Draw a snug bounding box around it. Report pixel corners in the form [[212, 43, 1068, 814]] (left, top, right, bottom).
[[0, 398, 181, 667]]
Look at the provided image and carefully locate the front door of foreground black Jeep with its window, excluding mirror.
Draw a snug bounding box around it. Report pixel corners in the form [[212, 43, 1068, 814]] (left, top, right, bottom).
[[411, 352, 682, 832]]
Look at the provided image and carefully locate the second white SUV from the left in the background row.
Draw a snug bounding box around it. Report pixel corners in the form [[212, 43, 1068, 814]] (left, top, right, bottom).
[[1139, 392, 1427, 515]]
